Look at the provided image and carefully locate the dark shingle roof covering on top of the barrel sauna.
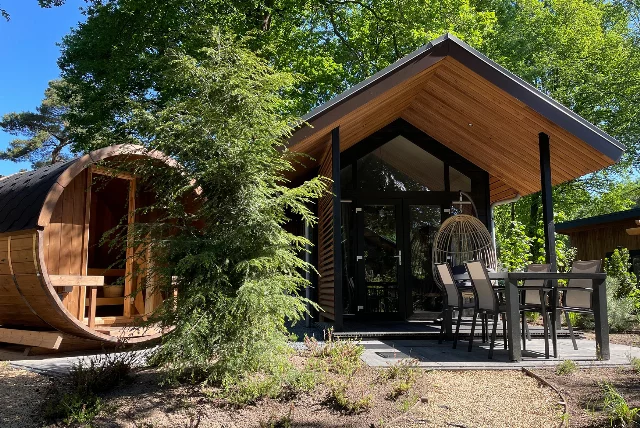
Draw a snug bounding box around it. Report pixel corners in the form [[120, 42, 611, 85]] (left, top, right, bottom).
[[0, 159, 77, 232]]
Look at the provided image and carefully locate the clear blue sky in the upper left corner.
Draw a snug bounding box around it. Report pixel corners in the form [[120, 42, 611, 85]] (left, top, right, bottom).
[[0, 0, 85, 175]]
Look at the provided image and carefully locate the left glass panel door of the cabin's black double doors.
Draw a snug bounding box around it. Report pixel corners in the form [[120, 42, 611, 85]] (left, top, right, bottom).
[[356, 201, 405, 315]]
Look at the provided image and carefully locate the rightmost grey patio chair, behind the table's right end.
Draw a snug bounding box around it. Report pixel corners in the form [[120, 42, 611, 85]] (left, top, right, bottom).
[[557, 260, 602, 351]]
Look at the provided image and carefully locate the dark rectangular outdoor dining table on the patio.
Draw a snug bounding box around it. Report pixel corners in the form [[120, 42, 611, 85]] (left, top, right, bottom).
[[454, 272, 610, 361]]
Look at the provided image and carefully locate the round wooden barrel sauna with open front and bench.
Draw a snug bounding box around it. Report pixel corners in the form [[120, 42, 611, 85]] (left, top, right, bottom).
[[0, 146, 170, 351]]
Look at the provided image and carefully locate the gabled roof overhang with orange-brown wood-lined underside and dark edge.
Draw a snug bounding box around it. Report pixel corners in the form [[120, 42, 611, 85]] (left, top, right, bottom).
[[289, 34, 625, 202]]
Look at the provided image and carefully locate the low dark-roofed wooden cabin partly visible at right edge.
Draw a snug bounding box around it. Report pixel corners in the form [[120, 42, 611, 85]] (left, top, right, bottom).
[[556, 208, 640, 277]]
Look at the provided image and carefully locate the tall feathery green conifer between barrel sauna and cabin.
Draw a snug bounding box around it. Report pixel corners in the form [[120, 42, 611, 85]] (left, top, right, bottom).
[[82, 31, 326, 385]]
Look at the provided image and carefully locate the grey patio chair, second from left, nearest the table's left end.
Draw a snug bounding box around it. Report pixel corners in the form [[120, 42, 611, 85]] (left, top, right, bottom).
[[464, 261, 507, 359]]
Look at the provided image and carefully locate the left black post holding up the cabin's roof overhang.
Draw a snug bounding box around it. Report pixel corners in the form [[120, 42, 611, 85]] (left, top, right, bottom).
[[331, 127, 343, 331]]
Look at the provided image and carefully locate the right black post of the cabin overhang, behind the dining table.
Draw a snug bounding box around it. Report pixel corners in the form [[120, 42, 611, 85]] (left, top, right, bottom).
[[538, 132, 559, 358]]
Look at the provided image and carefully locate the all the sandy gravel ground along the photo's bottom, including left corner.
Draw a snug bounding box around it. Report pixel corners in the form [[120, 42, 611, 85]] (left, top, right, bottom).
[[0, 356, 640, 428]]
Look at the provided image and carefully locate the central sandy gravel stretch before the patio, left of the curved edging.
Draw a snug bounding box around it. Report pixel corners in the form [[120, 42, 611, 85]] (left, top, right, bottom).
[[85, 367, 559, 428]]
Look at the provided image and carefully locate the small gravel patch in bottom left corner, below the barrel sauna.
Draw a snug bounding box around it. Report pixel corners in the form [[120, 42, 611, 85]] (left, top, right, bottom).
[[0, 363, 50, 428]]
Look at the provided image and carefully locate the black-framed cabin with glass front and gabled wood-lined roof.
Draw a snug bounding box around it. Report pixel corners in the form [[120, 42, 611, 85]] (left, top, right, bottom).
[[288, 34, 624, 329]]
